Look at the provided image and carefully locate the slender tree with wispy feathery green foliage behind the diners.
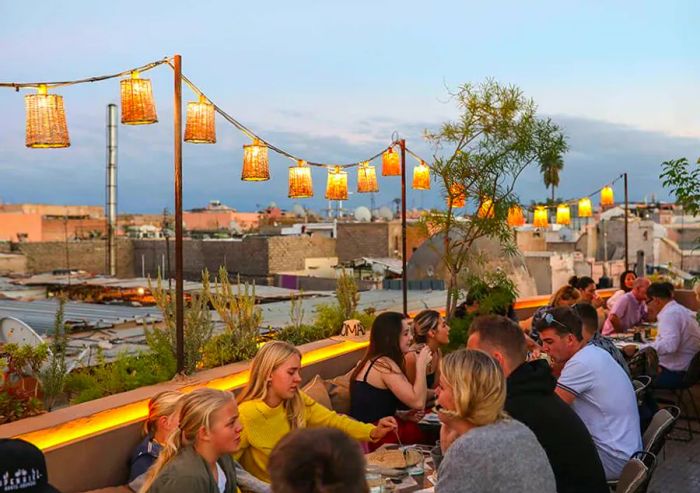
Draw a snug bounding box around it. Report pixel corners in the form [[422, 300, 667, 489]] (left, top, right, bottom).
[[423, 79, 568, 315]]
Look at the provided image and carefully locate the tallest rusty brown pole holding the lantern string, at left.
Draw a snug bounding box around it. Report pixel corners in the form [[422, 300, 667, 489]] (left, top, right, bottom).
[[173, 55, 185, 373]]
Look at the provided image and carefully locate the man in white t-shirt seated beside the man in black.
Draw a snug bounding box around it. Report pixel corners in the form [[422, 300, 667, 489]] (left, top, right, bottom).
[[537, 307, 642, 480]]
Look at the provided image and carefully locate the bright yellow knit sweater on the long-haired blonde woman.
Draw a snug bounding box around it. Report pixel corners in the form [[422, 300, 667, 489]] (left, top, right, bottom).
[[235, 392, 375, 483]]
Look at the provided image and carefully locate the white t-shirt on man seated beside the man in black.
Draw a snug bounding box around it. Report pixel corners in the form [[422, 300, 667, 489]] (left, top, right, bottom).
[[557, 345, 643, 480]]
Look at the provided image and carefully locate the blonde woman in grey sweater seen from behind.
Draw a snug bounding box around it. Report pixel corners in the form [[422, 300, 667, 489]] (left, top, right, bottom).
[[435, 349, 556, 493]]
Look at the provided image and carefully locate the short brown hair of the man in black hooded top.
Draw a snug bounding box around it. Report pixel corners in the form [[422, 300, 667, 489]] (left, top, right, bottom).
[[469, 315, 527, 367]]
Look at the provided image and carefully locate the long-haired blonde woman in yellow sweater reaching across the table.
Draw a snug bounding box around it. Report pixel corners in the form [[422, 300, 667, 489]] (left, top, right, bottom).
[[236, 341, 396, 482]]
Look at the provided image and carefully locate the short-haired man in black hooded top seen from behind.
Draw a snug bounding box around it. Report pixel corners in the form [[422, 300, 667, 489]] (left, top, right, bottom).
[[467, 315, 609, 493]]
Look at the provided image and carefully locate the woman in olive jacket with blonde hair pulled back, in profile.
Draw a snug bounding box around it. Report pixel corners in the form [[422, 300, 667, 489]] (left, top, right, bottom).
[[140, 388, 241, 493]]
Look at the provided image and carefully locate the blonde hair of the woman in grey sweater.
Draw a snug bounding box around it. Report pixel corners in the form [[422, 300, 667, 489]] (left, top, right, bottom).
[[441, 349, 507, 426]]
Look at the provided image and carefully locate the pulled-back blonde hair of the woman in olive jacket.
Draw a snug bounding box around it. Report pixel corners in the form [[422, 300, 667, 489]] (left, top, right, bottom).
[[139, 388, 235, 493]]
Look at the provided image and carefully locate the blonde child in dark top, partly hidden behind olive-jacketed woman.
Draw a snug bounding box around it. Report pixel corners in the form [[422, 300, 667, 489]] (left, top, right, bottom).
[[129, 390, 182, 491]]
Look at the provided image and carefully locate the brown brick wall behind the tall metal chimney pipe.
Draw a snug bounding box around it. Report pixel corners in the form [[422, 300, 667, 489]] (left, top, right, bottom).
[[16, 239, 134, 277]]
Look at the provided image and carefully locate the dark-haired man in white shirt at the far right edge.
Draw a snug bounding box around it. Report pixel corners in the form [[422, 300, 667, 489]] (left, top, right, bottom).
[[647, 282, 700, 389]]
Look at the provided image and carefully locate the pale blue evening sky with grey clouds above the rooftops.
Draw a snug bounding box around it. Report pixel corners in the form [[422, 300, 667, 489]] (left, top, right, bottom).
[[0, 0, 700, 212]]
